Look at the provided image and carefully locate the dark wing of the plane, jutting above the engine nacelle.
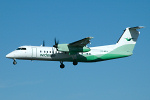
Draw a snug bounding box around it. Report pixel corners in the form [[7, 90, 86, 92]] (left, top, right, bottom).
[[68, 37, 93, 47]]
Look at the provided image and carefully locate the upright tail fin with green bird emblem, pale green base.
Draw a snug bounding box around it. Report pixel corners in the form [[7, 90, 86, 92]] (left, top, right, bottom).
[[116, 26, 144, 55]]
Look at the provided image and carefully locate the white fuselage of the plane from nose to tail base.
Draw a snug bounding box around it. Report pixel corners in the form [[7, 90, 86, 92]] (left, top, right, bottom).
[[6, 45, 114, 62]]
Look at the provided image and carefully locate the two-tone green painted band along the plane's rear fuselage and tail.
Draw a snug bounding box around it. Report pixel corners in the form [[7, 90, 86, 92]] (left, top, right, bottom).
[[78, 44, 135, 62]]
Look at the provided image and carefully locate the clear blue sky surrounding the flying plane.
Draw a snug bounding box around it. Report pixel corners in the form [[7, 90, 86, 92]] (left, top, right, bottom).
[[0, 0, 150, 100]]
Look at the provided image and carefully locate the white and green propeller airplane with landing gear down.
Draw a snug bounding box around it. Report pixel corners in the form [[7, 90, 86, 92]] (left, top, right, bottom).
[[6, 26, 144, 68]]
